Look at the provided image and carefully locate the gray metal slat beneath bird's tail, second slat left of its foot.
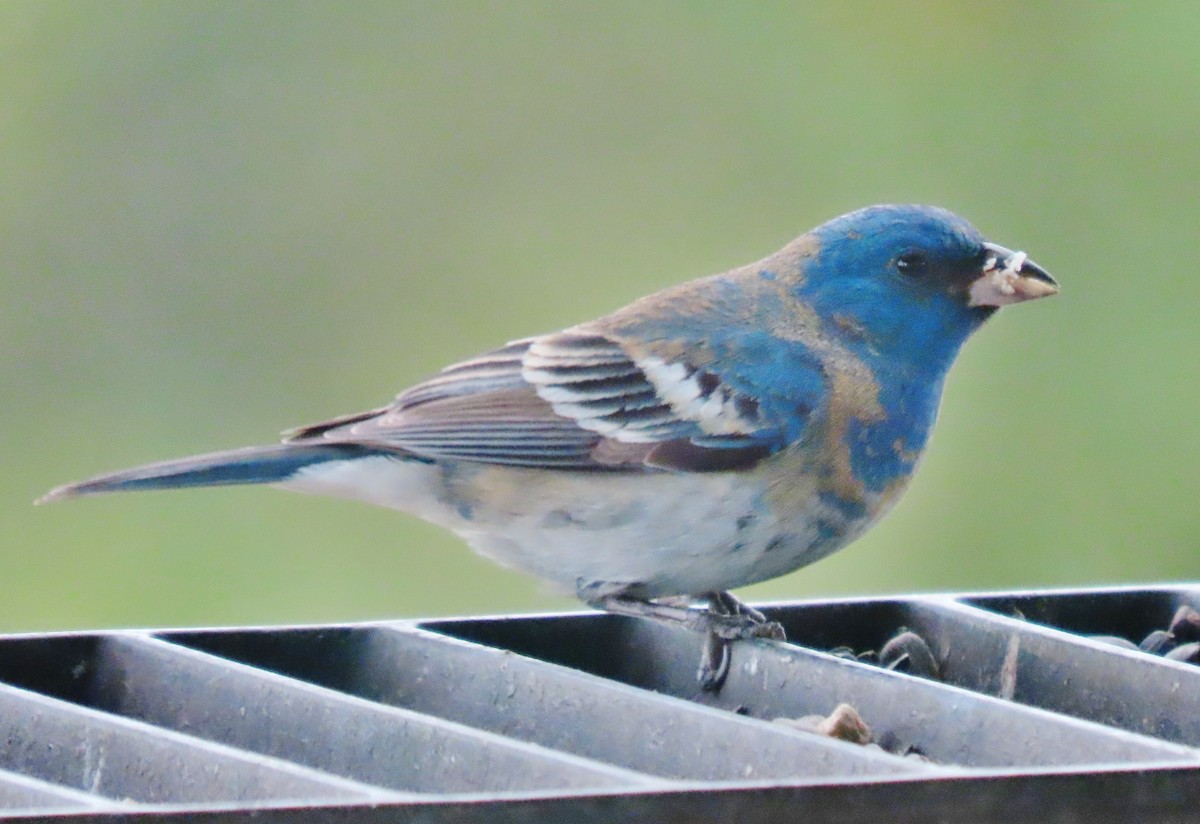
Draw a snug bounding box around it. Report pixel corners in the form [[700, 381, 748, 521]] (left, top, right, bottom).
[[89, 633, 662, 793]]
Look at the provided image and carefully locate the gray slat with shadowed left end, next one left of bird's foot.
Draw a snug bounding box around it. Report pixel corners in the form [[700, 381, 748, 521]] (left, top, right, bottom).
[[164, 617, 924, 781]]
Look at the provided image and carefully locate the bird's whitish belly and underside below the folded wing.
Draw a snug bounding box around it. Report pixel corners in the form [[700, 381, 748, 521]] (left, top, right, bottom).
[[278, 457, 869, 599]]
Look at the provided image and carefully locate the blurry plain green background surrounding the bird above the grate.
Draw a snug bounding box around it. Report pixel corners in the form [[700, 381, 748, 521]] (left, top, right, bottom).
[[0, 0, 1200, 631]]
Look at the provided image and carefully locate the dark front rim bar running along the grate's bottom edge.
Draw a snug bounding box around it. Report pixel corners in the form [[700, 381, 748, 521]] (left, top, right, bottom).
[[11, 766, 1200, 824]]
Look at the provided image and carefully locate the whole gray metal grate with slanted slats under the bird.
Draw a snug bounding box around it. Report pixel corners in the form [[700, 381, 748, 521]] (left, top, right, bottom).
[[0, 584, 1200, 824]]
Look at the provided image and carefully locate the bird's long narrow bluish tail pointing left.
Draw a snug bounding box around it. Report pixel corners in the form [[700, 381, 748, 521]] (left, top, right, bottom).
[[35, 444, 384, 504]]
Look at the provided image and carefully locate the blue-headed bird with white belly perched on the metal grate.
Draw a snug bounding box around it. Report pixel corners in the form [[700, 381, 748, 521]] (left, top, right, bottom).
[[38, 205, 1058, 690]]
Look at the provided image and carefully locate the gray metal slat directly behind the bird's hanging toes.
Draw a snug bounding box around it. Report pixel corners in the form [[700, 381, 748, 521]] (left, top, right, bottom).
[[433, 609, 1198, 766]]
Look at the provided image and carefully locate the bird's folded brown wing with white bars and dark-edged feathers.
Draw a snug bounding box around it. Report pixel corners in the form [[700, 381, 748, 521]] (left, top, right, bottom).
[[289, 332, 801, 471]]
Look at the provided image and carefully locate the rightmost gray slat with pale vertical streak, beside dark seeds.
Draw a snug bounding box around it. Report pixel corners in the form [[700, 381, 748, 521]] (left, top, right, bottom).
[[748, 588, 1200, 746]]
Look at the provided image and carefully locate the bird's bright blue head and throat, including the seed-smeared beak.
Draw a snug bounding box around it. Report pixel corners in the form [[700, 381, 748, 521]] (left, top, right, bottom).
[[794, 206, 1057, 492]]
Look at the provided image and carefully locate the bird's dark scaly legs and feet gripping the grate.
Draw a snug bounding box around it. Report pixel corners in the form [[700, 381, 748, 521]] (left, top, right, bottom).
[[588, 591, 785, 692]]
